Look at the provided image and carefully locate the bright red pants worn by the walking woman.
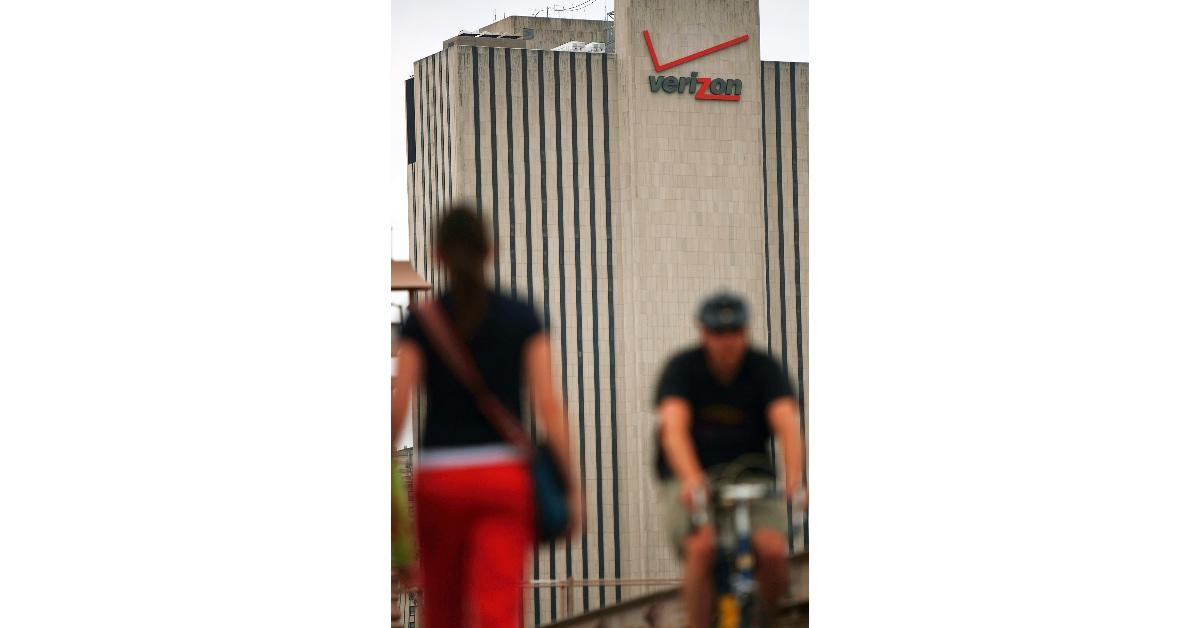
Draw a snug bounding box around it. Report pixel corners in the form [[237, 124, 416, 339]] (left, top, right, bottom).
[[414, 462, 534, 628]]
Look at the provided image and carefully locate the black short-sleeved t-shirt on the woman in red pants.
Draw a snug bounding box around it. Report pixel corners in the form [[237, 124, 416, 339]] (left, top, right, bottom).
[[400, 292, 544, 448]]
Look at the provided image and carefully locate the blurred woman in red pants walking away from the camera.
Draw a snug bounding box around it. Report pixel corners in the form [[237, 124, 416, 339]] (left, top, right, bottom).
[[391, 208, 580, 628]]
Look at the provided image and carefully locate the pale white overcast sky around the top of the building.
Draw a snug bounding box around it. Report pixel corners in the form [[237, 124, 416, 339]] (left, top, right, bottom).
[[391, 0, 809, 259]]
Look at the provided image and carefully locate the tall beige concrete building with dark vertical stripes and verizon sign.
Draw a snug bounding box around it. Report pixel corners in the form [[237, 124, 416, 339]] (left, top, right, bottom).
[[406, 0, 808, 623]]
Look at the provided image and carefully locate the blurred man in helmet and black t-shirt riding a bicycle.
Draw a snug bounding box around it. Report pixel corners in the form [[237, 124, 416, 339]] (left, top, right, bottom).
[[655, 292, 804, 628]]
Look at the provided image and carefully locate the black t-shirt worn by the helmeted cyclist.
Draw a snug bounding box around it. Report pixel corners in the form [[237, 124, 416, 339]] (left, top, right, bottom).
[[654, 347, 796, 479]]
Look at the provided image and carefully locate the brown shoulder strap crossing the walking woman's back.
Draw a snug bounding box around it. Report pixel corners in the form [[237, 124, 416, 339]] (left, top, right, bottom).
[[415, 299, 532, 454]]
